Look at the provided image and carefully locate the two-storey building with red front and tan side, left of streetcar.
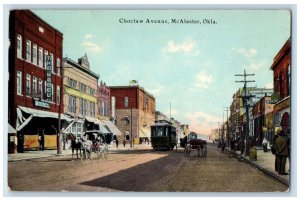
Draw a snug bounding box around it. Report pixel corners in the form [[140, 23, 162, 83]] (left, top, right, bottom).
[[110, 85, 155, 144]]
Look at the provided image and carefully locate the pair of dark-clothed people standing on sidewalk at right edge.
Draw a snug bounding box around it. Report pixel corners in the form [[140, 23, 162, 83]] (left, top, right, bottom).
[[271, 129, 290, 175]]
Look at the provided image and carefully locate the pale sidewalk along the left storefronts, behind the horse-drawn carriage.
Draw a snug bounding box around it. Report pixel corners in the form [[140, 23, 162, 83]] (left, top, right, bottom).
[[7, 144, 152, 162]]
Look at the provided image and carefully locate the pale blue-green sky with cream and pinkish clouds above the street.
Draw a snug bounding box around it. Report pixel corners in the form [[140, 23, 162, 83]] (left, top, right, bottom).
[[33, 10, 291, 135]]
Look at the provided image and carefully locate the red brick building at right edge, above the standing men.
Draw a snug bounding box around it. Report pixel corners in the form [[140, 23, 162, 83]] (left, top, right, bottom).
[[271, 38, 291, 131]]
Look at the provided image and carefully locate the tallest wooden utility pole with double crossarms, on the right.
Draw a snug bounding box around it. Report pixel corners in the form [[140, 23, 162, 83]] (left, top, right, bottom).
[[235, 70, 255, 156]]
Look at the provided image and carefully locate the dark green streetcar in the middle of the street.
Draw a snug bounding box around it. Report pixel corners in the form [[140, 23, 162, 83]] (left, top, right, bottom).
[[151, 120, 177, 150]]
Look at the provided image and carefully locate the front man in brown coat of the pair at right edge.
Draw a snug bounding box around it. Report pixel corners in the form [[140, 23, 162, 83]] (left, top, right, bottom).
[[274, 130, 288, 175]]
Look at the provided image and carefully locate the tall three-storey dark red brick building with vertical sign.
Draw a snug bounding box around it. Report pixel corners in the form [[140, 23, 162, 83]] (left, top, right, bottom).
[[8, 10, 67, 152]]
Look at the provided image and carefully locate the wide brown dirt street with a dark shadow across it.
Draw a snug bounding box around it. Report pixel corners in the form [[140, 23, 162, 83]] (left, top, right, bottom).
[[8, 144, 288, 192]]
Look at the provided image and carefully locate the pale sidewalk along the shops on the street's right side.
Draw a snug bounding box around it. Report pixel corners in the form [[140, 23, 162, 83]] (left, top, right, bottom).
[[231, 147, 290, 185]]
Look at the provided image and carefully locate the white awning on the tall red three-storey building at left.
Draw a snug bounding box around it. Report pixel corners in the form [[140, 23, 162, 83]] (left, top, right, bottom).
[[16, 106, 72, 131]]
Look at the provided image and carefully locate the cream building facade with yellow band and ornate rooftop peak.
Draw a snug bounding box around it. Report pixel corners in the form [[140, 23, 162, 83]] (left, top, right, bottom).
[[63, 54, 99, 137]]
